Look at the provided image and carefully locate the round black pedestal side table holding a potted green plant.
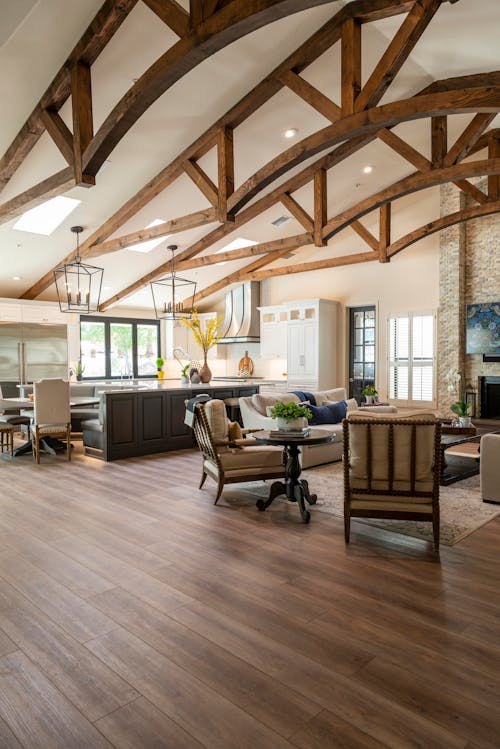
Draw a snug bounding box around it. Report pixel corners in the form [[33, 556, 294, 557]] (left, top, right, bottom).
[[253, 429, 335, 523]]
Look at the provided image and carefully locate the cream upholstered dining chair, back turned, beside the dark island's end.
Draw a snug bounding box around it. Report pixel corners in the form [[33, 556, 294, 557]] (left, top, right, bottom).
[[30, 378, 71, 463]]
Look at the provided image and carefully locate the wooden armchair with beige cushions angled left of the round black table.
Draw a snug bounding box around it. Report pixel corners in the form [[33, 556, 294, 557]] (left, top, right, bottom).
[[193, 399, 285, 504]]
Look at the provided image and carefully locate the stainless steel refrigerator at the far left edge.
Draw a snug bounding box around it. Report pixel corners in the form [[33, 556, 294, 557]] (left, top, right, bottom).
[[0, 322, 68, 384]]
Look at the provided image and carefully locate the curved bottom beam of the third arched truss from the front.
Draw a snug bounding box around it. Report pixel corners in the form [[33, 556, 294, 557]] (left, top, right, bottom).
[[323, 158, 500, 239]]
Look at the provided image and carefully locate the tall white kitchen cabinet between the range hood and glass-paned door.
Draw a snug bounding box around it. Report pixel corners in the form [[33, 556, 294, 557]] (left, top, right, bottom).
[[286, 299, 338, 390]]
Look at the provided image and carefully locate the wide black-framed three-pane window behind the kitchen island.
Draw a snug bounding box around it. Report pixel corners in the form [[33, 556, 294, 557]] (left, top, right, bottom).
[[80, 317, 160, 379]]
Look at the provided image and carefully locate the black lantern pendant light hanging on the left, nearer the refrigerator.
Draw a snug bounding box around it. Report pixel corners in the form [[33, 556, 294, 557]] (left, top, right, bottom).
[[54, 226, 104, 315]]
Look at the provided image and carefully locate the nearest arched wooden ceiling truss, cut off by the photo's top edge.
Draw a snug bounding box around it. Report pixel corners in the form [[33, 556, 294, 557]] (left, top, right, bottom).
[[0, 0, 344, 199]]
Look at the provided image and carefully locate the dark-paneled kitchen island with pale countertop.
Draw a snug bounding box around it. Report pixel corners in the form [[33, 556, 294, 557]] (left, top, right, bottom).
[[82, 381, 258, 460]]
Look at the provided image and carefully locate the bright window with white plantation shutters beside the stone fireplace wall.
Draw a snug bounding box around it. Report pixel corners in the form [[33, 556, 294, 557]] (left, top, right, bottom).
[[388, 312, 435, 405]]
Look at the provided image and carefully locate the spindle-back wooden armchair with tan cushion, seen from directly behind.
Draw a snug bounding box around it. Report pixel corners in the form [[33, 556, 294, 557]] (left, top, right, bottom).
[[343, 413, 441, 551]]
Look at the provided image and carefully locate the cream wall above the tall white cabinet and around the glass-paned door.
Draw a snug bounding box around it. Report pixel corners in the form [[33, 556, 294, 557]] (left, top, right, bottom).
[[261, 234, 439, 399]]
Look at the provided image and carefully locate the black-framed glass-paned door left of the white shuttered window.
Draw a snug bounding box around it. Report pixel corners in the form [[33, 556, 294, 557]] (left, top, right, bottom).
[[349, 306, 376, 403]]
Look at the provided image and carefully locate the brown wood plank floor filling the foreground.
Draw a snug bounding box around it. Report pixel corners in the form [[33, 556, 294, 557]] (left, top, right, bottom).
[[0, 442, 500, 749]]
